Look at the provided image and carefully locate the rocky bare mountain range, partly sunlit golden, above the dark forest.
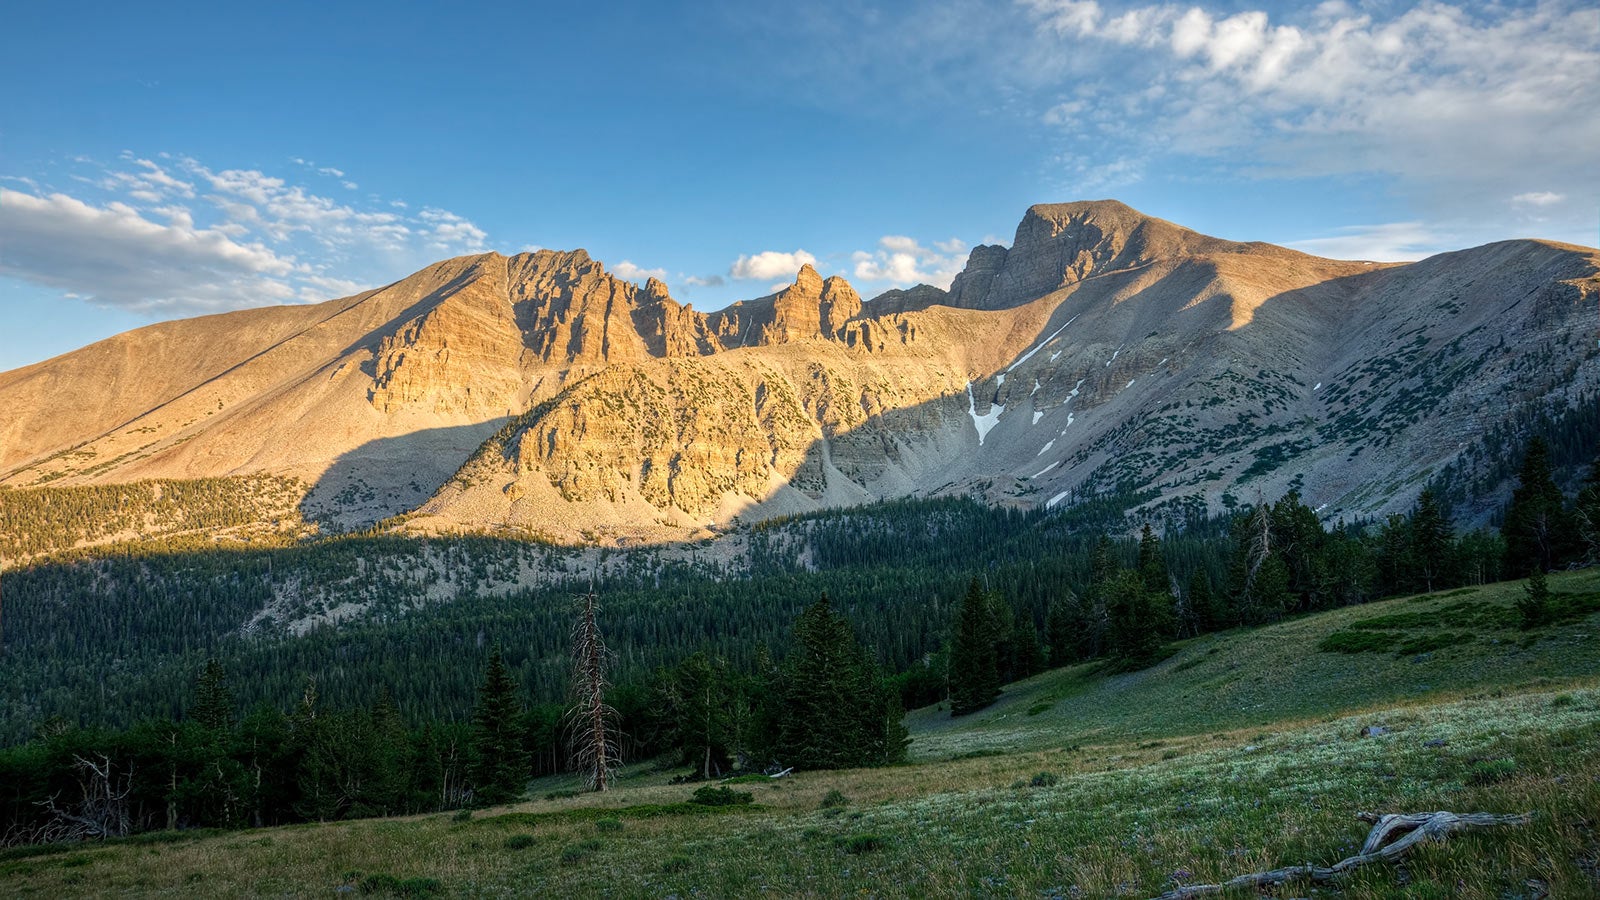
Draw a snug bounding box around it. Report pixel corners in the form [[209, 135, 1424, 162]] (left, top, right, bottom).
[[0, 202, 1600, 543]]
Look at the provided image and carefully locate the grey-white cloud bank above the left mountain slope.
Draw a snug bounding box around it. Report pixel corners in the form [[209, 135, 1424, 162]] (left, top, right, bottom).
[[0, 152, 488, 315]]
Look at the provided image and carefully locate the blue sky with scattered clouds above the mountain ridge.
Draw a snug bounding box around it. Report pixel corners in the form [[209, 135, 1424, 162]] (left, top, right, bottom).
[[0, 0, 1600, 370]]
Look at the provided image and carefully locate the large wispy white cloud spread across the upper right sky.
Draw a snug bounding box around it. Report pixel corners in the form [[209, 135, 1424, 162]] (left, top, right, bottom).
[[1019, 0, 1600, 204]]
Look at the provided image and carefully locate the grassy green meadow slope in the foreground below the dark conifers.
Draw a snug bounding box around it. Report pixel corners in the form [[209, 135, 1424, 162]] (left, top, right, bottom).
[[0, 572, 1600, 898]]
